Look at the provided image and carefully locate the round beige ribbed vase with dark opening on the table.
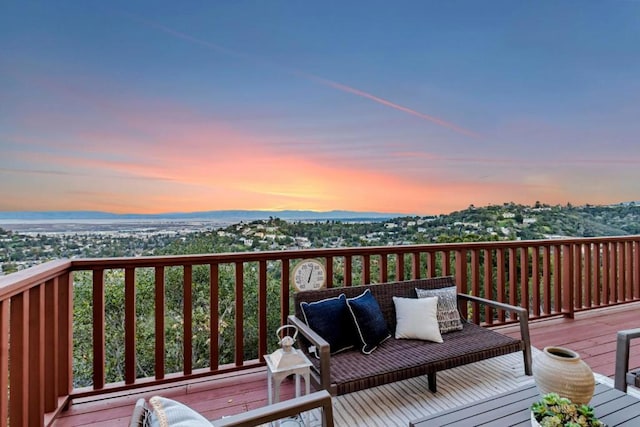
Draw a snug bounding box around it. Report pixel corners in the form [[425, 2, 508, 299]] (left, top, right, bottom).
[[533, 347, 595, 404]]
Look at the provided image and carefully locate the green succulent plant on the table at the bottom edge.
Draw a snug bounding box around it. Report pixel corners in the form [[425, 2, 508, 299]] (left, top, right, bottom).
[[531, 393, 606, 427]]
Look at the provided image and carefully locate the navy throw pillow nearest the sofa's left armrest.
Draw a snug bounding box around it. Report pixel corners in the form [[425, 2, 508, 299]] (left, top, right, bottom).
[[300, 294, 353, 357]]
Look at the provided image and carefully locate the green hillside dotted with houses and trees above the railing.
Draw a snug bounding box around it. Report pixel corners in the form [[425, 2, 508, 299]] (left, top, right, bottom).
[[0, 202, 640, 274]]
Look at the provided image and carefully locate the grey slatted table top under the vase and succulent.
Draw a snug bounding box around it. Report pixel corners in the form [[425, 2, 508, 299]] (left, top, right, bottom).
[[409, 384, 640, 427]]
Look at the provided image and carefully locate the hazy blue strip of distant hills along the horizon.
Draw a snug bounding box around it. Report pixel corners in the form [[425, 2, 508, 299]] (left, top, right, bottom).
[[0, 210, 404, 222]]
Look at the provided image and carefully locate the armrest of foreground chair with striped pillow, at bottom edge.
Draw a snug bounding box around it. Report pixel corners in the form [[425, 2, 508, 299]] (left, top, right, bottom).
[[211, 390, 333, 427]]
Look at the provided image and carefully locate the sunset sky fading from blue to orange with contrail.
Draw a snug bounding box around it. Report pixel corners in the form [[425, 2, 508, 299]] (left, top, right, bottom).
[[0, 0, 640, 215]]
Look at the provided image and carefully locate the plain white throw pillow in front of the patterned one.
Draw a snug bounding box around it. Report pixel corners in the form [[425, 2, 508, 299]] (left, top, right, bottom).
[[393, 297, 442, 342]]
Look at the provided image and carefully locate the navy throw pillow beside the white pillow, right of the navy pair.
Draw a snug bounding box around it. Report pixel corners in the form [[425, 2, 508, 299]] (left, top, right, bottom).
[[347, 289, 391, 354]]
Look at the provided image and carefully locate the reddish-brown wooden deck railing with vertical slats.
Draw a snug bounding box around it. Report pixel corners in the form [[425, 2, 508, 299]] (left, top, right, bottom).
[[0, 236, 640, 426]]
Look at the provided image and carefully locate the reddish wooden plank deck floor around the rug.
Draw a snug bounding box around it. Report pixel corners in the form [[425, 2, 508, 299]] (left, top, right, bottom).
[[53, 302, 640, 427]]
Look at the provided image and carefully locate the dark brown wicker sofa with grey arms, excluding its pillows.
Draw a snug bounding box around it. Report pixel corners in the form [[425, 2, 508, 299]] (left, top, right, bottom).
[[288, 276, 532, 395]]
